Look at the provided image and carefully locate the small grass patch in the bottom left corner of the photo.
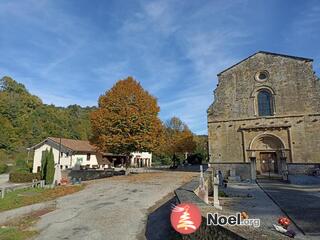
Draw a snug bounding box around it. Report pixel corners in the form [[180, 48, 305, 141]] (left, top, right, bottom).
[[0, 209, 54, 240]]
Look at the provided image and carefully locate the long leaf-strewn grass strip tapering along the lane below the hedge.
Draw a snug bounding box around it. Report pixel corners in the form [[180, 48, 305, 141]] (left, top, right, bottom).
[[0, 185, 84, 212]]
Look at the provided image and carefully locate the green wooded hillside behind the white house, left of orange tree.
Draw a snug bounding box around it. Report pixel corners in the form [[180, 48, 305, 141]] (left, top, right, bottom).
[[0, 77, 94, 160]]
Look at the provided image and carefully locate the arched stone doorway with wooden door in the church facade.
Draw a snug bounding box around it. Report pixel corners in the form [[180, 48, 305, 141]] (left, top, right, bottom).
[[250, 134, 285, 175]]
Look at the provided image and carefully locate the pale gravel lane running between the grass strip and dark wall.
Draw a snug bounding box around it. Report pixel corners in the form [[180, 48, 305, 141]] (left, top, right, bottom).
[[35, 171, 194, 240]]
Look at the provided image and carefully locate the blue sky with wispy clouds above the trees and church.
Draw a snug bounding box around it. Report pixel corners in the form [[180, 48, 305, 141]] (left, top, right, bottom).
[[0, 0, 320, 134]]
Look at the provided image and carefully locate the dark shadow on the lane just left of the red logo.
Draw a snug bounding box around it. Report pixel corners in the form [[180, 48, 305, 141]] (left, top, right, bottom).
[[145, 197, 182, 240]]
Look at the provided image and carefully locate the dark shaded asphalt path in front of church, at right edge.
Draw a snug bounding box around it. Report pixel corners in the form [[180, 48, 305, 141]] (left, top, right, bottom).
[[258, 179, 320, 238]]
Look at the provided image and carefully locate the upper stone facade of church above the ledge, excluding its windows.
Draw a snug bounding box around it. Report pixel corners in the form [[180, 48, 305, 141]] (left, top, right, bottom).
[[208, 53, 320, 122]]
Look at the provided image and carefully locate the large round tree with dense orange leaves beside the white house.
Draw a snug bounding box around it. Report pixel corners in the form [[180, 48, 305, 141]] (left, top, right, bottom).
[[91, 77, 163, 156]]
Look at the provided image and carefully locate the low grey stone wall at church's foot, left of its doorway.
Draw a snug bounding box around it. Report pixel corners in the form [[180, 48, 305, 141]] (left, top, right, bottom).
[[210, 162, 251, 180]]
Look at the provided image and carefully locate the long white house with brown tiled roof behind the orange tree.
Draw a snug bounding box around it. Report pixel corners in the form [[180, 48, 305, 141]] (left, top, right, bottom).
[[30, 137, 152, 173]]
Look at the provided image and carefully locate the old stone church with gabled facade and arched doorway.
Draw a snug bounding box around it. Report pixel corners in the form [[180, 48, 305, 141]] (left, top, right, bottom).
[[207, 51, 320, 177]]
